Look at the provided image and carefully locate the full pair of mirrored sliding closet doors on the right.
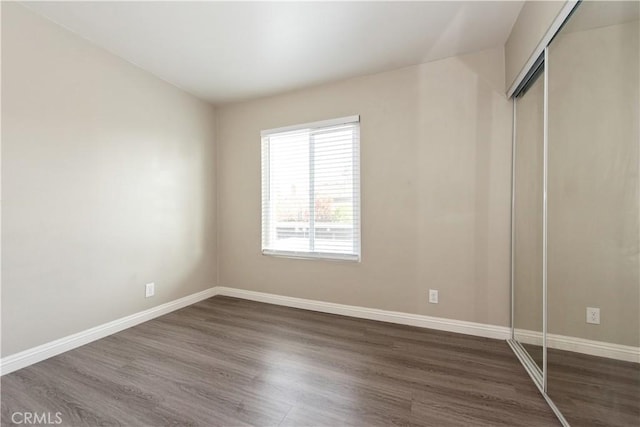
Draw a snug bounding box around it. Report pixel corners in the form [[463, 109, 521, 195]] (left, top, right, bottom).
[[509, 1, 640, 426]]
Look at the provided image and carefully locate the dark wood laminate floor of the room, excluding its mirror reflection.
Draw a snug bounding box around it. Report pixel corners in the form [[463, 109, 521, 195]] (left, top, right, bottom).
[[2, 296, 559, 426]]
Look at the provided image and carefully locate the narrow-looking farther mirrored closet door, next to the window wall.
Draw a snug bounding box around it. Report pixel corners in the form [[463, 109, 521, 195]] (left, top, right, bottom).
[[513, 72, 544, 372]]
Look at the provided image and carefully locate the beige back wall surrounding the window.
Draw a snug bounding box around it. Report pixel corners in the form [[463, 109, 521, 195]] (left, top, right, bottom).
[[217, 48, 511, 325]]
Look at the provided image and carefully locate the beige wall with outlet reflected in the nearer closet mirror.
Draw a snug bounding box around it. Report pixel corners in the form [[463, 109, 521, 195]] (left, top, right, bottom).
[[548, 19, 640, 346]]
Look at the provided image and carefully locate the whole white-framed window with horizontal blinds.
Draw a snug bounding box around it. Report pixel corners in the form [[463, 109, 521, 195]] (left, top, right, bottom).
[[261, 116, 360, 261]]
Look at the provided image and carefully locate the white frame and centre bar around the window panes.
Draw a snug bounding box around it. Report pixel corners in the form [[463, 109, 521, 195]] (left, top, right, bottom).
[[260, 115, 362, 262]]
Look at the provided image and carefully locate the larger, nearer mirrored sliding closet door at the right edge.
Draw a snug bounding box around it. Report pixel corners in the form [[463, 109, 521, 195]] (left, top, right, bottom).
[[536, 2, 640, 426]]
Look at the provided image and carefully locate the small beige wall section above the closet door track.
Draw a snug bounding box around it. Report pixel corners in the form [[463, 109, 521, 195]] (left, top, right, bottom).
[[505, 0, 566, 90]]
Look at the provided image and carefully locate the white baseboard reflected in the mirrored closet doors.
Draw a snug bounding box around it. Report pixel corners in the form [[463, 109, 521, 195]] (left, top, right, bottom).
[[515, 329, 640, 363]]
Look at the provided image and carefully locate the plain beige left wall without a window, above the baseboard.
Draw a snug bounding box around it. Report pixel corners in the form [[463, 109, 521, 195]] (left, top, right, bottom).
[[2, 2, 216, 356]]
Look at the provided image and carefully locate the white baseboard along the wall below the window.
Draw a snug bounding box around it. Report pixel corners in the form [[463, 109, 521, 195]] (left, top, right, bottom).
[[216, 286, 511, 339]]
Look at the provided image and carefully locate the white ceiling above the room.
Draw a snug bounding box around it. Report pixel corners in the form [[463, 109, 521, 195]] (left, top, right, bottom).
[[25, 1, 523, 104]]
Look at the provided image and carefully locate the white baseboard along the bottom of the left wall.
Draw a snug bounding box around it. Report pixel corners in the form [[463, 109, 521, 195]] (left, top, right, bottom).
[[0, 288, 216, 375]]
